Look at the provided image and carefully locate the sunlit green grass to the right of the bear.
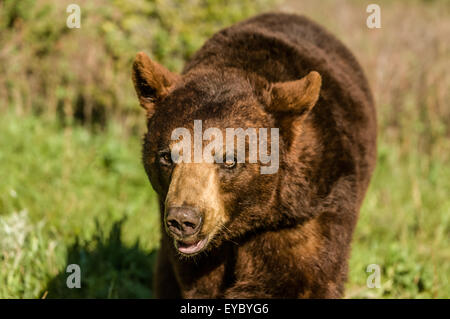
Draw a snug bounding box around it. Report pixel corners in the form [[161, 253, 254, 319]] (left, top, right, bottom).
[[347, 143, 450, 298]]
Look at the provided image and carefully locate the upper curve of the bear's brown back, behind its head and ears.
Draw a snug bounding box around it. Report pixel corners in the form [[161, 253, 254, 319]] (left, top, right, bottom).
[[183, 13, 372, 103]]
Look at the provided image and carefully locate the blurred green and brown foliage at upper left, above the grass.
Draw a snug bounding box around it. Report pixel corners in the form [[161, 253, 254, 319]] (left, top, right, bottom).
[[0, 0, 273, 126]]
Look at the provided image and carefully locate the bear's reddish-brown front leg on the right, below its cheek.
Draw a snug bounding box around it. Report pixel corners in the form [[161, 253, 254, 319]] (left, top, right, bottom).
[[223, 220, 343, 298]]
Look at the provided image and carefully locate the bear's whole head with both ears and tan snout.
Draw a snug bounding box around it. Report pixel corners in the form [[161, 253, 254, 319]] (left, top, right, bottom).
[[133, 53, 321, 256]]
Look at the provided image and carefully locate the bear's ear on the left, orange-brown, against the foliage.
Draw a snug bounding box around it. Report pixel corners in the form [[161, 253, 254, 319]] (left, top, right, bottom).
[[132, 52, 179, 118]]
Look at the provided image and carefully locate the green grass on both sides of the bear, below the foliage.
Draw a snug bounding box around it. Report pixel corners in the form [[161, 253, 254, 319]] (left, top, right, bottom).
[[0, 113, 450, 298]]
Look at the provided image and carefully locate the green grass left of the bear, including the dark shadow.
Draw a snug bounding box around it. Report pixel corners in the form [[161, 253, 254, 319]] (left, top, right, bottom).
[[0, 113, 159, 298]]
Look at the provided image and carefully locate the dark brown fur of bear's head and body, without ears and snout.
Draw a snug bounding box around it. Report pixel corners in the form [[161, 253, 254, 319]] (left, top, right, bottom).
[[138, 14, 376, 298]]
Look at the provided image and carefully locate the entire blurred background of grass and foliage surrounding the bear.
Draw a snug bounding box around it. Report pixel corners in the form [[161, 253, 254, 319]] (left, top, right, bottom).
[[0, 0, 450, 298]]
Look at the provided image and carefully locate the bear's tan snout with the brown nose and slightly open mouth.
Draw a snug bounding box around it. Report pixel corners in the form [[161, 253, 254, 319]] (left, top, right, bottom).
[[163, 163, 228, 256]]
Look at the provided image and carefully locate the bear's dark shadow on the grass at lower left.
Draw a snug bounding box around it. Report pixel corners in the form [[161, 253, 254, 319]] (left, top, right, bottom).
[[41, 220, 156, 298]]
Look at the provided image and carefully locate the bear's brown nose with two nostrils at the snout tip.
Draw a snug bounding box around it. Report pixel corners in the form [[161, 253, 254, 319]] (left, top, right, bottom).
[[166, 207, 202, 237]]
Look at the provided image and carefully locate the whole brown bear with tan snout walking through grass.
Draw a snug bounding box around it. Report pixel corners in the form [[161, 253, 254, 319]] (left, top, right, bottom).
[[132, 13, 377, 298]]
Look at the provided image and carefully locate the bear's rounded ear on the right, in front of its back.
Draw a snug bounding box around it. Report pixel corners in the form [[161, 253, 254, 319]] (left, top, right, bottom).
[[266, 71, 322, 148]]
